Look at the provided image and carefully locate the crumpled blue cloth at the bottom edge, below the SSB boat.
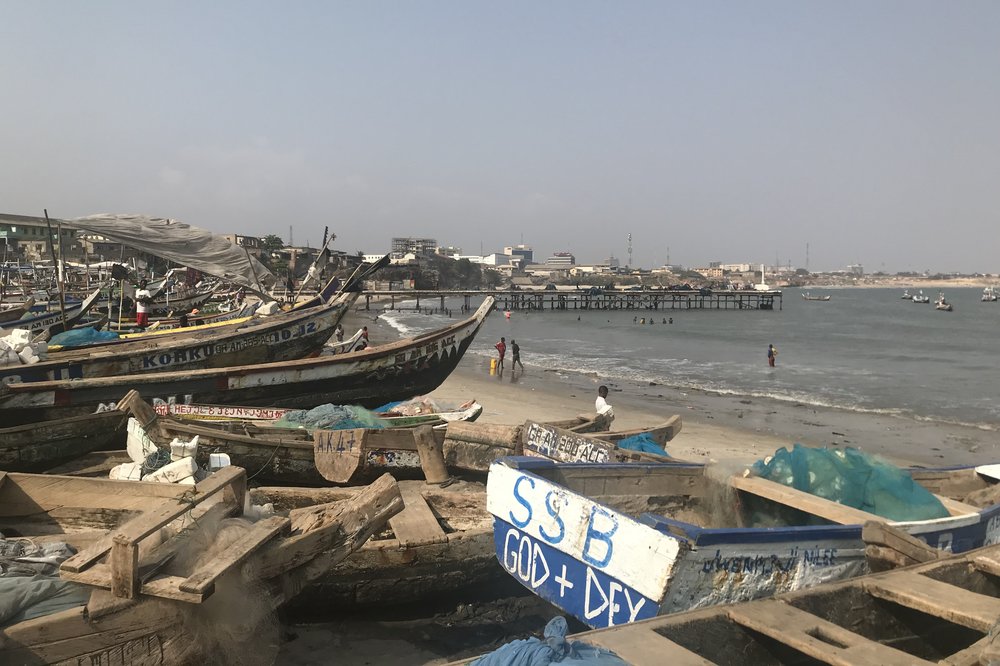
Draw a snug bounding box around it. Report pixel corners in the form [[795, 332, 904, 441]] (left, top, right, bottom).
[[470, 616, 628, 666]]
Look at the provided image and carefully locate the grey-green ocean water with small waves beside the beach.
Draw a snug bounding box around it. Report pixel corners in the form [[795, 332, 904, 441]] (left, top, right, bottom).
[[382, 288, 1000, 430]]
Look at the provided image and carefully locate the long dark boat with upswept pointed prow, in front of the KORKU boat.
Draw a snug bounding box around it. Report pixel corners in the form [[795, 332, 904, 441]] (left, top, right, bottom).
[[0, 297, 493, 423]]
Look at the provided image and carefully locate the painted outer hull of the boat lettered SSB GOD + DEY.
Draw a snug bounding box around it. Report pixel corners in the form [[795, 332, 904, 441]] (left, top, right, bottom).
[[487, 459, 1000, 628]]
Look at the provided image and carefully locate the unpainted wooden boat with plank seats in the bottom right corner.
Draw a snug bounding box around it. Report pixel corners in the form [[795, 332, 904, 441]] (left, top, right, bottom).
[[552, 545, 1000, 666]]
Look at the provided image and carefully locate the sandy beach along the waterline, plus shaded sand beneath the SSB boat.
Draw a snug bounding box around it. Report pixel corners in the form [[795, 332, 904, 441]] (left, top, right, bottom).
[[281, 313, 998, 666]]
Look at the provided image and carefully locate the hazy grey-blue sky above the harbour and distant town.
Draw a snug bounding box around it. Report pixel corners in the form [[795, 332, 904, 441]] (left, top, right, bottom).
[[0, 0, 1000, 272]]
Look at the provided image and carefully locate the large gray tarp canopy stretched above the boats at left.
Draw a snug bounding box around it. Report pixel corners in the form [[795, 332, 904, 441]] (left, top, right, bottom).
[[63, 214, 277, 291]]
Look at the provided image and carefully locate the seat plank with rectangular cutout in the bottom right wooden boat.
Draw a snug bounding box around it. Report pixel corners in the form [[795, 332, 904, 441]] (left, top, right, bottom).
[[727, 599, 932, 666]]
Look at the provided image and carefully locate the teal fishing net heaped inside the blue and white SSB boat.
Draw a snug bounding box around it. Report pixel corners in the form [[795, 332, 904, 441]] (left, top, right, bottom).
[[751, 444, 949, 521]]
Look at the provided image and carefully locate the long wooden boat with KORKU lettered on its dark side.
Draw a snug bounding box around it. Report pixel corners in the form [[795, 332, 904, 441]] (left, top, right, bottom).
[[0, 276, 358, 386]]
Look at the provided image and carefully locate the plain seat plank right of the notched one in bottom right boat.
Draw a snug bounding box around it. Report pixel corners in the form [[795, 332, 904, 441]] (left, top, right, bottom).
[[863, 571, 1000, 633]]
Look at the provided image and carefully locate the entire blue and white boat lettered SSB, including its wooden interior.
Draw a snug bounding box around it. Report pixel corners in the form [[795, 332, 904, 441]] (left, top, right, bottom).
[[487, 457, 1000, 628]]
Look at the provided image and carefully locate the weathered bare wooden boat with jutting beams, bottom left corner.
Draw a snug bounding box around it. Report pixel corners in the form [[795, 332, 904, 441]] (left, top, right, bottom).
[[0, 467, 403, 664]]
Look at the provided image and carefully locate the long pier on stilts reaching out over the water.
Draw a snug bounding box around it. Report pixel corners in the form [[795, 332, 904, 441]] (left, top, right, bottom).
[[362, 288, 782, 312]]
